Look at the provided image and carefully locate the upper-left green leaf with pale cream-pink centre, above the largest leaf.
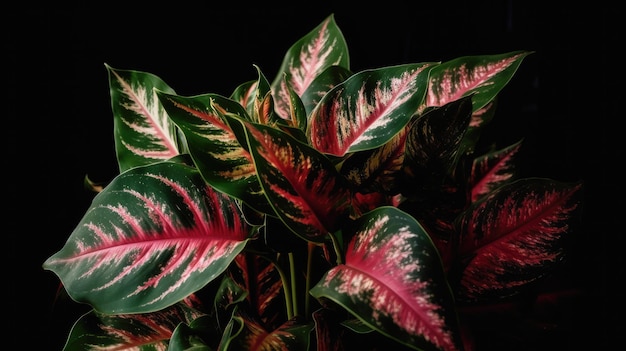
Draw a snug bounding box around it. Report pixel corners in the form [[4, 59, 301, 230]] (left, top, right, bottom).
[[106, 65, 180, 172]]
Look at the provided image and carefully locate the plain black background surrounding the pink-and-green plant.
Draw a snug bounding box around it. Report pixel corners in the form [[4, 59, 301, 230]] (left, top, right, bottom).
[[8, 0, 626, 350]]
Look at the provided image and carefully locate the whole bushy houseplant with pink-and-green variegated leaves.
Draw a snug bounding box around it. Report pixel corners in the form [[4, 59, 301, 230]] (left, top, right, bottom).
[[43, 15, 582, 351]]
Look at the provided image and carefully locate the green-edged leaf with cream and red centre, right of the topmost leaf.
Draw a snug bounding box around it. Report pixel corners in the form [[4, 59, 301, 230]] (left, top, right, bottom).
[[307, 63, 431, 156]]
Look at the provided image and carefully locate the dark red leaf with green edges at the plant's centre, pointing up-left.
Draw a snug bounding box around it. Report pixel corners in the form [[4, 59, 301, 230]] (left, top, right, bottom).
[[245, 123, 350, 242]]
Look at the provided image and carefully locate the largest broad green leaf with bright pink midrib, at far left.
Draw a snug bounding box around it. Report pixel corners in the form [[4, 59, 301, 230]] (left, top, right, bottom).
[[43, 162, 251, 313]]
